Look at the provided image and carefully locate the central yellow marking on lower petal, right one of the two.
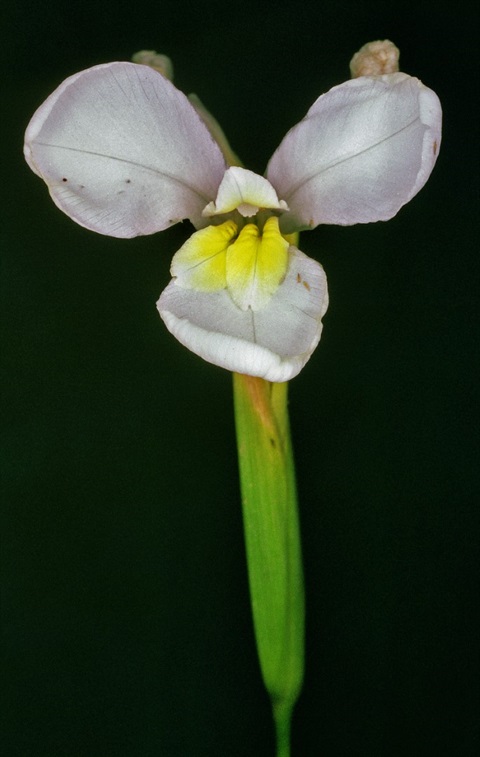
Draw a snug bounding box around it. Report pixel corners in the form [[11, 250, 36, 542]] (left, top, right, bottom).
[[227, 216, 289, 310]]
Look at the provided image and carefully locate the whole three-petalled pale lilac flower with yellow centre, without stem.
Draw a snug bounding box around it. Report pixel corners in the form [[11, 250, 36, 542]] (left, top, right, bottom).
[[25, 57, 441, 381]]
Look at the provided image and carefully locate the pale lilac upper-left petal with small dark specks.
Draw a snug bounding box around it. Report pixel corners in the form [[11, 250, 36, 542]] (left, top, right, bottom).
[[25, 63, 226, 237]]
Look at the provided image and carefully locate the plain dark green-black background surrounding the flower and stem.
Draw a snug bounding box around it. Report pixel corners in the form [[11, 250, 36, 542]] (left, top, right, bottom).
[[0, 0, 480, 757]]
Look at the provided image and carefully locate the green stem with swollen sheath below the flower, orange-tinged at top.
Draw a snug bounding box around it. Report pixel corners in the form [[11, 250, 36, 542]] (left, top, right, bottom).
[[234, 374, 305, 757]]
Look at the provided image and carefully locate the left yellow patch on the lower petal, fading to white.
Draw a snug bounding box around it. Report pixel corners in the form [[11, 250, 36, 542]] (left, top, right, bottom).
[[170, 221, 238, 292]]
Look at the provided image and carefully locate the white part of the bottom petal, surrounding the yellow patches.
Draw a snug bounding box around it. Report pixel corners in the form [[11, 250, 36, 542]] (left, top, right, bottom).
[[157, 246, 328, 382]]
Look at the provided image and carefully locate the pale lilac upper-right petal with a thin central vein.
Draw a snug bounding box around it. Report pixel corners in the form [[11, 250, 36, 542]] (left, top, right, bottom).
[[266, 73, 442, 233]]
